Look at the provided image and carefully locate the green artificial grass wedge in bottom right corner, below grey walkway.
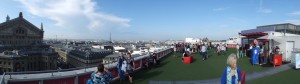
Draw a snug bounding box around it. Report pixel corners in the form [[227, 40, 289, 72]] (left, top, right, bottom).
[[246, 69, 300, 84]]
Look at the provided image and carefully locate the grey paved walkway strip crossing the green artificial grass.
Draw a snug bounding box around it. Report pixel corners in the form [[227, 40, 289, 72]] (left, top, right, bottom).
[[149, 64, 292, 84]]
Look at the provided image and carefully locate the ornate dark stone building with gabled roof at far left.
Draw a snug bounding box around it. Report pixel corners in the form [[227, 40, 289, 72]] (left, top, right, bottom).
[[0, 12, 58, 72]]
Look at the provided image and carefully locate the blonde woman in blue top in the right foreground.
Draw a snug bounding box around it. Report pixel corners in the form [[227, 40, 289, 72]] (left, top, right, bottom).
[[221, 54, 242, 84]]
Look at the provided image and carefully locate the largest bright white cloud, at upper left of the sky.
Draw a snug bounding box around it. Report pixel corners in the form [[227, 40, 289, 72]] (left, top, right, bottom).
[[18, 0, 130, 30]]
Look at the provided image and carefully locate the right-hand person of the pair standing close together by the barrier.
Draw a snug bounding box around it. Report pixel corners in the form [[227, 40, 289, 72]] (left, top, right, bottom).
[[126, 53, 135, 84]]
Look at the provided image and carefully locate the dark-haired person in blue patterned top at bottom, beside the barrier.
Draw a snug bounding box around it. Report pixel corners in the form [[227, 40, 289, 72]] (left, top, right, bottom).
[[91, 64, 112, 84]]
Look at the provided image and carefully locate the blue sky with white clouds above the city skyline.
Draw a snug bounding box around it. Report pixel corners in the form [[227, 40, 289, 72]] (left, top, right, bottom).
[[0, 0, 300, 40]]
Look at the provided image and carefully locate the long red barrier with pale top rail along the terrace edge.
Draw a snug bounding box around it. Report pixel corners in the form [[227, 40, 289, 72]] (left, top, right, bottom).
[[1, 48, 173, 84]]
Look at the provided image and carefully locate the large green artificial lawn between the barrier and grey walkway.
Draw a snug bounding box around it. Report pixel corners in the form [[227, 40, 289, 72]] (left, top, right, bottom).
[[134, 49, 265, 84]]
